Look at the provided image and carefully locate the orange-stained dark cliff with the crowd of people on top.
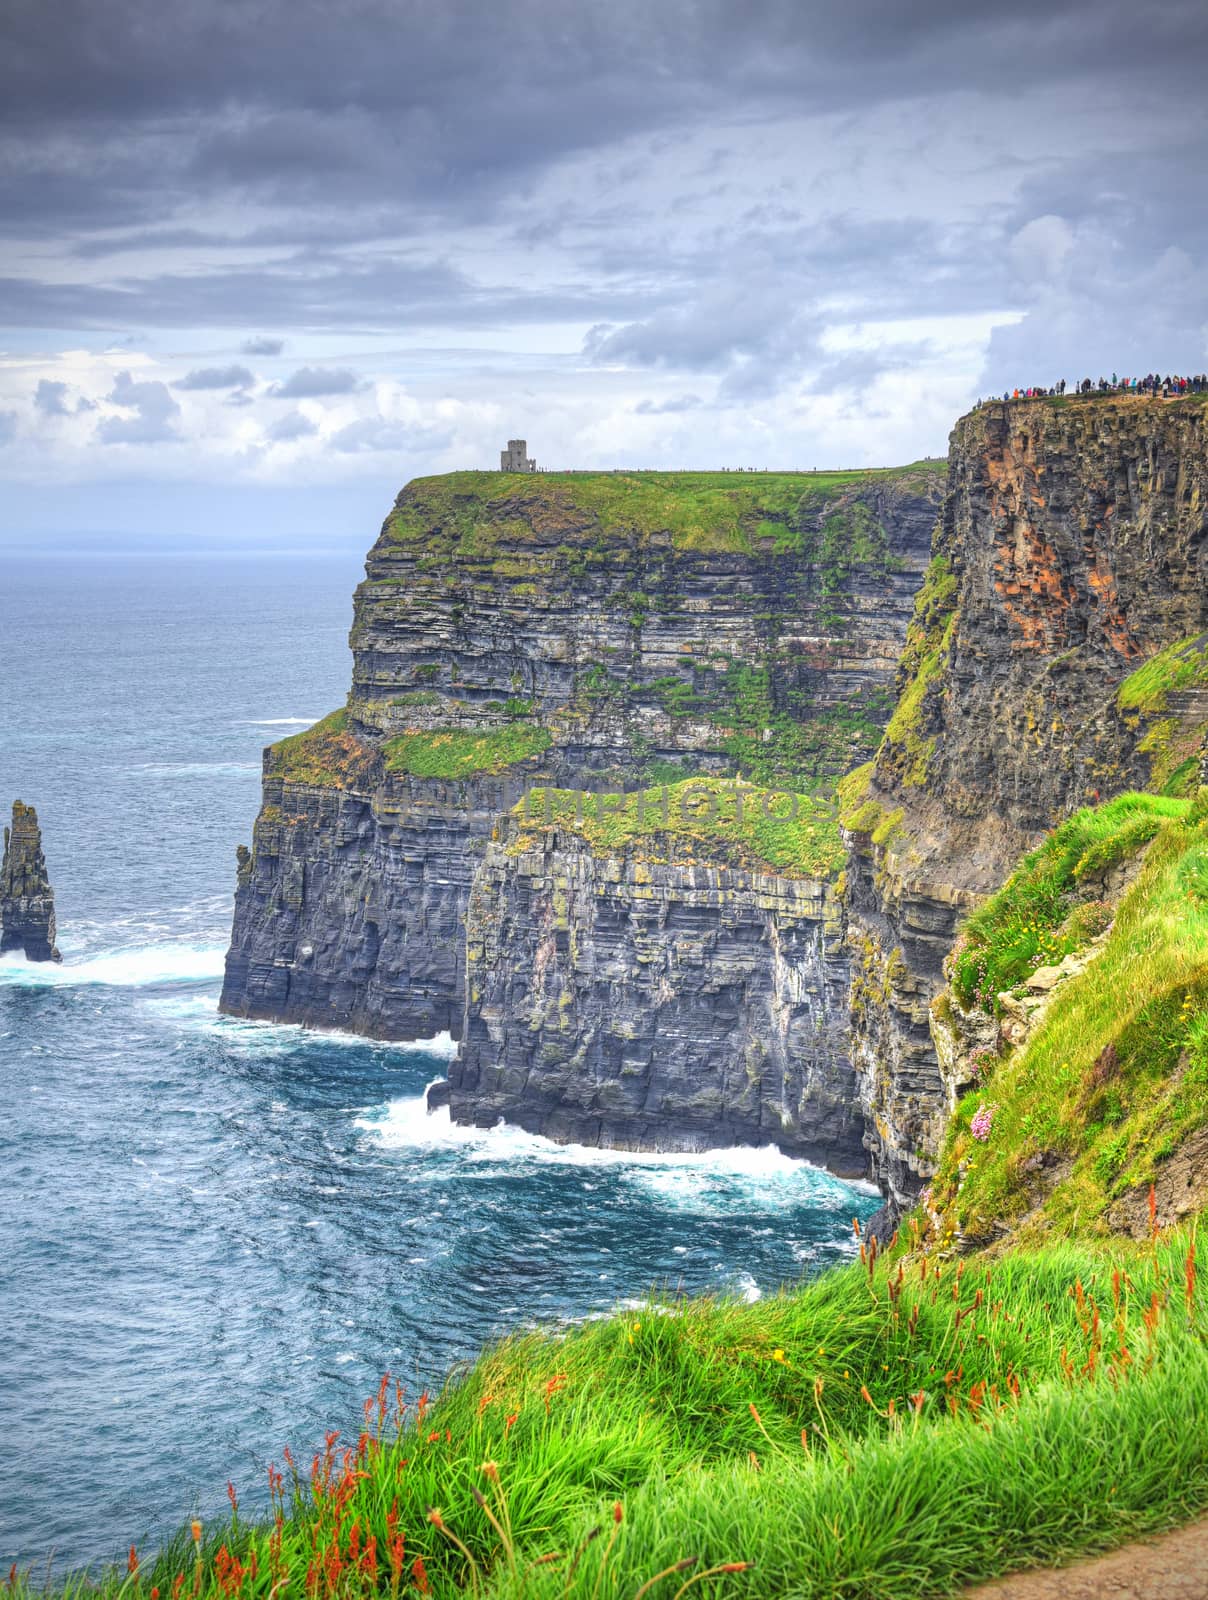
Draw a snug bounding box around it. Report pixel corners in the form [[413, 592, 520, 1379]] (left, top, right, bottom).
[[845, 398, 1208, 1206]]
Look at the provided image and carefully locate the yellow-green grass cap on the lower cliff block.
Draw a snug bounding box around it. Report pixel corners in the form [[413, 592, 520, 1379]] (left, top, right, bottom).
[[517, 778, 843, 878]]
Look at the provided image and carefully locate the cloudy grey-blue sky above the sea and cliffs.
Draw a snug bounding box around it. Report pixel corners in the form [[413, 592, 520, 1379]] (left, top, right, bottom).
[[0, 0, 1208, 550]]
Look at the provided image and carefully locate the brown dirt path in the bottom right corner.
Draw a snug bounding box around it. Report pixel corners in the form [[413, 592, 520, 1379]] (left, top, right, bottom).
[[965, 1520, 1208, 1600]]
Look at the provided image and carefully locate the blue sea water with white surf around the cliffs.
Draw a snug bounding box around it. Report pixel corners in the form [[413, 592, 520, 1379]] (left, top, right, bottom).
[[0, 555, 877, 1566]]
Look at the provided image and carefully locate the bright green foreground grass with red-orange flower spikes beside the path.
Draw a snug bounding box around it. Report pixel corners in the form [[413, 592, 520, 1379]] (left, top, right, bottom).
[[18, 1234, 1208, 1600]]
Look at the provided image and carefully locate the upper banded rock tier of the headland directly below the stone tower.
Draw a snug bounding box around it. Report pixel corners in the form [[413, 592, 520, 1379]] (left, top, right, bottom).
[[349, 467, 941, 782]]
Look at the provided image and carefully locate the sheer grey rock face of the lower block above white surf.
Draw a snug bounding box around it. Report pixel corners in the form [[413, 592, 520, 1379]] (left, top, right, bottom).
[[450, 818, 867, 1174]]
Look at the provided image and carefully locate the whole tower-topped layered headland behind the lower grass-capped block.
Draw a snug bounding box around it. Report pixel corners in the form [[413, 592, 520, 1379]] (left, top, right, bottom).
[[221, 462, 942, 1062]]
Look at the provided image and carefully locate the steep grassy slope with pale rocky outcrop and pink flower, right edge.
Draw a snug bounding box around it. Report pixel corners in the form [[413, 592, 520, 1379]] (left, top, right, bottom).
[[923, 789, 1208, 1246]]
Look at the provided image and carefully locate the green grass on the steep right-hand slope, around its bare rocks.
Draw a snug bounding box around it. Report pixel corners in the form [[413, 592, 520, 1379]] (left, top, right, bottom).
[[931, 795, 1208, 1238]]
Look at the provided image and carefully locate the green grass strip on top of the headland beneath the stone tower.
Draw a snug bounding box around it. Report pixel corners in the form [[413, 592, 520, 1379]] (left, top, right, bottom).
[[387, 461, 946, 555]]
